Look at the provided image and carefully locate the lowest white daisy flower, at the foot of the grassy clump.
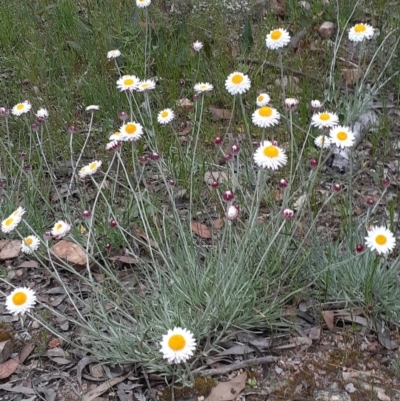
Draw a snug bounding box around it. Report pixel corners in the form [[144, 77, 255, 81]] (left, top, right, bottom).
[[160, 327, 196, 363]]
